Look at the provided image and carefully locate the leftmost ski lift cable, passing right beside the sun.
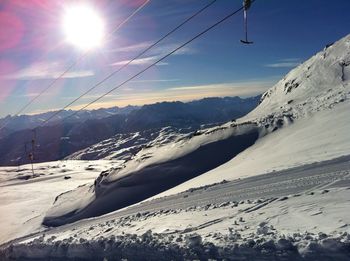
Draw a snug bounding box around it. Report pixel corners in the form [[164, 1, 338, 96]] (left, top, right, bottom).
[[0, 0, 151, 130]]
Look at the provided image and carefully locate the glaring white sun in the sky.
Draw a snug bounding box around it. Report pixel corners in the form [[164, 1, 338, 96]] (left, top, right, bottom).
[[63, 5, 105, 50]]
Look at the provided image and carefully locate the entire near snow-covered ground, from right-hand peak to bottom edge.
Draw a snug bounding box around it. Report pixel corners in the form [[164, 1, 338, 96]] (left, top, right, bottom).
[[0, 35, 350, 260]]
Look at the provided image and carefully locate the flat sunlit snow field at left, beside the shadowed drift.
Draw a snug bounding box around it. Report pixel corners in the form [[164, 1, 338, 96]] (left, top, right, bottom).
[[0, 161, 119, 243]]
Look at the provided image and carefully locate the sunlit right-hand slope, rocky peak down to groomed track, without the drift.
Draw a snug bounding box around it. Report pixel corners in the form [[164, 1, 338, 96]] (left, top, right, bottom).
[[160, 35, 350, 196]]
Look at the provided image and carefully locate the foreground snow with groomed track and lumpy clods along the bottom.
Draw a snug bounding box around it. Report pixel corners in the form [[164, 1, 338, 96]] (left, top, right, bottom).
[[3, 156, 350, 260]]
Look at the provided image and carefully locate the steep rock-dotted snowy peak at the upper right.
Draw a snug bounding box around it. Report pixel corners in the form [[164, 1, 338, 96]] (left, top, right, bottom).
[[242, 35, 350, 120]]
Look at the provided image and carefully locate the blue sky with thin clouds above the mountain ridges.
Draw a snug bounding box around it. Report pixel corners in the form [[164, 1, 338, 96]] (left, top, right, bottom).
[[0, 0, 350, 116]]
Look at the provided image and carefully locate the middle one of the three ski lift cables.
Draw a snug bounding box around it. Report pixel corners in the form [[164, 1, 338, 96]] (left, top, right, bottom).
[[40, 0, 217, 126]]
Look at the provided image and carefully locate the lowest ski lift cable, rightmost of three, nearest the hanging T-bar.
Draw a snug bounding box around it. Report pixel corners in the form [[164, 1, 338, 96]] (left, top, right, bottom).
[[63, 0, 255, 120]]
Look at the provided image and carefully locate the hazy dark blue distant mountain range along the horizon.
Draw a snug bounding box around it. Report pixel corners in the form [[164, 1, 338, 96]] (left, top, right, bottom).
[[0, 96, 260, 166]]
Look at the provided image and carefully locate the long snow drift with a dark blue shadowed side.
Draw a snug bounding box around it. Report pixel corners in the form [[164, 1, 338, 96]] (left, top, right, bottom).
[[43, 123, 259, 226]]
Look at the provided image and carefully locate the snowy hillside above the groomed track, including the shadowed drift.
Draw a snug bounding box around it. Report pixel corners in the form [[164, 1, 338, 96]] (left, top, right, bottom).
[[44, 35, 350, 228]]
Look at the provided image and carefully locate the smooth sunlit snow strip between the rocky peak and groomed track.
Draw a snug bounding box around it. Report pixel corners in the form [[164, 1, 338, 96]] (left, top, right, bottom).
[[158, 99, 350, 197]]
